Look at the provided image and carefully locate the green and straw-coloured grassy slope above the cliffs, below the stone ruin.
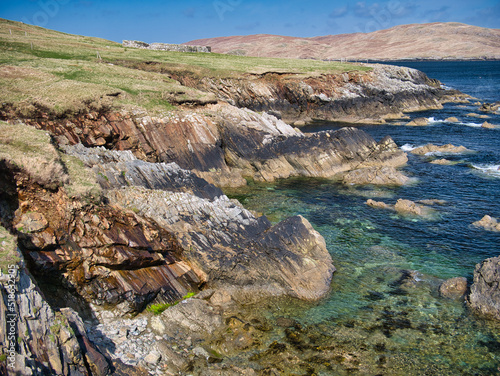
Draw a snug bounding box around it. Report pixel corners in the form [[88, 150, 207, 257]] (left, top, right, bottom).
[[0, 19, 367, 116]]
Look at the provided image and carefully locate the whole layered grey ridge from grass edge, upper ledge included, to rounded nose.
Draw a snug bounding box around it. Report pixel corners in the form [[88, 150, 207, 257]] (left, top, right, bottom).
[[66, 142, 335, 300]]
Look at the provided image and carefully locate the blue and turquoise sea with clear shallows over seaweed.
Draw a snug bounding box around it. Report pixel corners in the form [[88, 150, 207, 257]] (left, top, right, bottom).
[[227, 61, 500, 375]]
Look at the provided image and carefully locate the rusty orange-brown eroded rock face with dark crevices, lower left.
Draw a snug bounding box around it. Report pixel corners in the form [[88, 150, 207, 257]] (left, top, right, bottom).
[[8, 172, 201, 313]]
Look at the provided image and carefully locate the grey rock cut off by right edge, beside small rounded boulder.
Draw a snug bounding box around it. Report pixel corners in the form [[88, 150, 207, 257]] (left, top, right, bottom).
[[468, 257, 500, 320]]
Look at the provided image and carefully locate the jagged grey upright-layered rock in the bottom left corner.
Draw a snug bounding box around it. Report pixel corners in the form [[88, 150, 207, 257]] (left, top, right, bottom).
[[0, 267, 111, 376]]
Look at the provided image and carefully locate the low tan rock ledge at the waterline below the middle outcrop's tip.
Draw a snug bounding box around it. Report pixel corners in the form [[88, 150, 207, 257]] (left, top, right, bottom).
[[342, 167, 410, 185]]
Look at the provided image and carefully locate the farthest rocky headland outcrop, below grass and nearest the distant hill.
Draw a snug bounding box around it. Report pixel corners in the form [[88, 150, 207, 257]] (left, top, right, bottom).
[[172, 65, 461, 123]]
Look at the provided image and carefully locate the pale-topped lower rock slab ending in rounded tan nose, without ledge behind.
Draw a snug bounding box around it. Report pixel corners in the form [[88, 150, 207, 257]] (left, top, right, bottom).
[[108, 188, 335, 300]]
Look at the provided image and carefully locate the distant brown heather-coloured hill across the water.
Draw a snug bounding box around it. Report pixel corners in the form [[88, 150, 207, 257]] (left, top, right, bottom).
[[185, 22, 500, 60]]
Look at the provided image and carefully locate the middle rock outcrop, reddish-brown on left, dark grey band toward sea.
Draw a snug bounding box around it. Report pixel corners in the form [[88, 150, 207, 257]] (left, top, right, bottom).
[[14, 105, 407, 186]]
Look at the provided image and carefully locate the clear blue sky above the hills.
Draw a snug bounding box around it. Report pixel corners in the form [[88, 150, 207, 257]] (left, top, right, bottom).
[[0, 0, 500, 43]]
